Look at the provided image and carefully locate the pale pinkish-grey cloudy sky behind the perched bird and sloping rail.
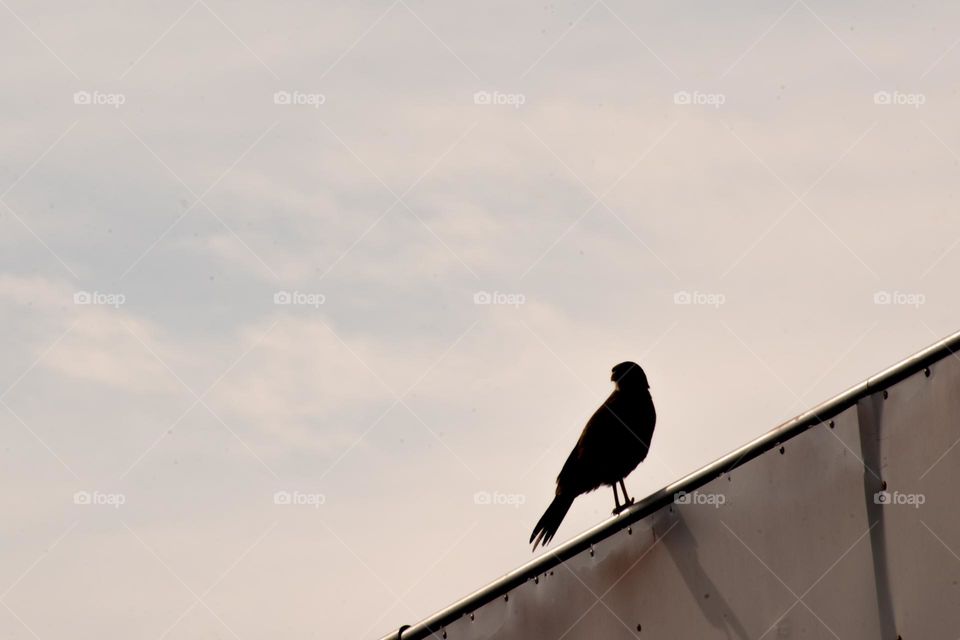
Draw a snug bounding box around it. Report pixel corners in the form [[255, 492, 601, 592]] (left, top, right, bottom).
[[0, 0, 960, 640]]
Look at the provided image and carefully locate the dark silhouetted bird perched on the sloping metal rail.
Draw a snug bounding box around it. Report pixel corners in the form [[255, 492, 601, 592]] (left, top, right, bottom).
[[530, 362, 657, 551]]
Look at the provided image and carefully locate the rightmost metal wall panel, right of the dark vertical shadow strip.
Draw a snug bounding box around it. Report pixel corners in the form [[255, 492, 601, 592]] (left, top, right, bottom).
[[859, 357, 960, 638]]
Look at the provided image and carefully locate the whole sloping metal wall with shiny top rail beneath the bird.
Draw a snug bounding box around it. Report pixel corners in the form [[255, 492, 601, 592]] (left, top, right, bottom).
[[384, 334, 960, 640]]
